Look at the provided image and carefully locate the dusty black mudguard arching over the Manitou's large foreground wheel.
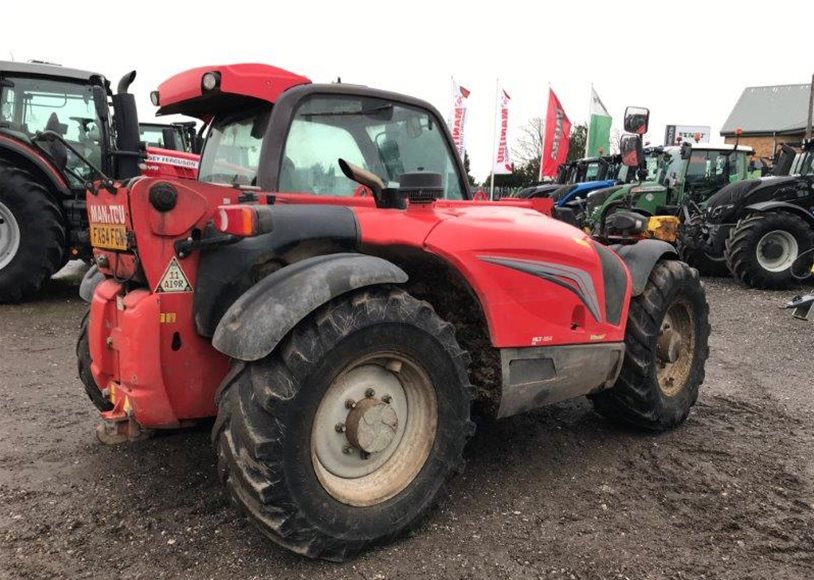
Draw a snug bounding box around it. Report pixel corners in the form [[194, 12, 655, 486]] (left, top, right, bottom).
[[212, 253, 407, 361]]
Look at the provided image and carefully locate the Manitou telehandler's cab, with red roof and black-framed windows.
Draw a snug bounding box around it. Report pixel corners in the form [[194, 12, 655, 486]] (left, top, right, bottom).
[[152, 64, 471, 200]]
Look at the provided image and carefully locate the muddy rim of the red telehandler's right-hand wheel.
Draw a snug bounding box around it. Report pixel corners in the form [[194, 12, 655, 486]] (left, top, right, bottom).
[[656, 301, 695, 397]]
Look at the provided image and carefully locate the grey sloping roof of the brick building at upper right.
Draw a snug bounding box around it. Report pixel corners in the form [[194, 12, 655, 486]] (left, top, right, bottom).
[[721, 84, 811, 135]]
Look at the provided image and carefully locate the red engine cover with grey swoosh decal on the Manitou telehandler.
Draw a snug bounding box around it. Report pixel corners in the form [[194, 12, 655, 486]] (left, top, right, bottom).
[[356, 202, 630, 348]]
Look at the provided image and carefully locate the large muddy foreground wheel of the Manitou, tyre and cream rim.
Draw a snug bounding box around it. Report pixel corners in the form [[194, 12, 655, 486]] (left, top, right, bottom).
[[213, 289, 474, 561]]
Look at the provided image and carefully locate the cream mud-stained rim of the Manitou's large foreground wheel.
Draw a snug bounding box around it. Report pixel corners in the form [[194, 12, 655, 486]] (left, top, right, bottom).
[[311, 352, 438, 506]]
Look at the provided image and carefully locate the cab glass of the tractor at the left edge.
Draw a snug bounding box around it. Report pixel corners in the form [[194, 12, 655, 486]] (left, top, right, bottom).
[[0, 77, 102, 185]]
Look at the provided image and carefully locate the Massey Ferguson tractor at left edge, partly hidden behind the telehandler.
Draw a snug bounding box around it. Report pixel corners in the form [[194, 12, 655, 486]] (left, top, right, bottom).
[[0, 62, 197, 302]]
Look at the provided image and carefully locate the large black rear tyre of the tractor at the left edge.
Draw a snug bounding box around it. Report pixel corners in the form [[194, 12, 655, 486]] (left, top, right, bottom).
[[0, 164, 65, 302]]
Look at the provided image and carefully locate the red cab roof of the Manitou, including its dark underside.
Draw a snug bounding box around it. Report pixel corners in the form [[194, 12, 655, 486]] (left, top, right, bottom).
[[156, 63, 311, 118]]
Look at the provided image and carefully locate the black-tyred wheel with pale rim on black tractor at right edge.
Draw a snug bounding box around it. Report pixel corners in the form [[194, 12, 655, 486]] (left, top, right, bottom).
[[726, 212, 814, 290]]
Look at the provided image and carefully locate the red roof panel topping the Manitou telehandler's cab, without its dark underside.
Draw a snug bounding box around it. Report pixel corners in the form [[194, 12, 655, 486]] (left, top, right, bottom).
[[158, 63, 311, 114]]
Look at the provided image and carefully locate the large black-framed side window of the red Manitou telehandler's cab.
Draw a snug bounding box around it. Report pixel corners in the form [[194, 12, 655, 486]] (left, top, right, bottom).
[[279, 95, 464, 199]]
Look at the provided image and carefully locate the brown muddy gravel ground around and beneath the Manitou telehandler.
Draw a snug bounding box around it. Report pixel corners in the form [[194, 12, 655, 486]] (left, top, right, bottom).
[[0, 266, 814, 580]]
